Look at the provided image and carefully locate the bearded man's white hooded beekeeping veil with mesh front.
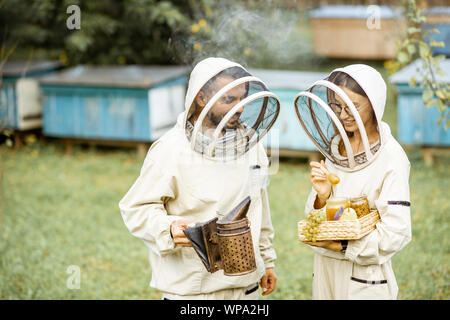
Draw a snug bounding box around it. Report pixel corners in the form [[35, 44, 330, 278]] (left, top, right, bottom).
[[184, 58, 280, 159]]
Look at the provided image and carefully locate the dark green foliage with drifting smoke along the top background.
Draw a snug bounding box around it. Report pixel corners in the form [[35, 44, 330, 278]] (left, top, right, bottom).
[[0, 0, 323, 68]]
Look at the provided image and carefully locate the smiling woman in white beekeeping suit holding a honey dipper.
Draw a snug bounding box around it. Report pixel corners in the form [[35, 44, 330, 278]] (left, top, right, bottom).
[[295, 64, 411, 299]]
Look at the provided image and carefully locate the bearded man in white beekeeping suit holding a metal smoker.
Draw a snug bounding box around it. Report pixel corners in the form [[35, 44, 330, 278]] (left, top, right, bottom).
[[119, 58, 280, 300]]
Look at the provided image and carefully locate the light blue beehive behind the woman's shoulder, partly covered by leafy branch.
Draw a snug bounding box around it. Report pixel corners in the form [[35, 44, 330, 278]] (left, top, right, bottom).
[[389, 59, 450, 146]]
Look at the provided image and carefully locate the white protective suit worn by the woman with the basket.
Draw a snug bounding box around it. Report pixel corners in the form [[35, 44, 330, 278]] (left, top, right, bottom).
[[296, 65, 411, 299]]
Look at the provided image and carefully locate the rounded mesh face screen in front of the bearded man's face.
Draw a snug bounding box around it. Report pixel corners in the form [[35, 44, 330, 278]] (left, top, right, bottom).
[[186, 69, 280, 159]]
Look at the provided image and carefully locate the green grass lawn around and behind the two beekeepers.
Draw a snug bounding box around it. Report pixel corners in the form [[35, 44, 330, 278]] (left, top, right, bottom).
[[0, 138, 450, 299]]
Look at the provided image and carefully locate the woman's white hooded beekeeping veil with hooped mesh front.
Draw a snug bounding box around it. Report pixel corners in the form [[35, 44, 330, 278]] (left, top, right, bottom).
[[294, 64, 386, 171]]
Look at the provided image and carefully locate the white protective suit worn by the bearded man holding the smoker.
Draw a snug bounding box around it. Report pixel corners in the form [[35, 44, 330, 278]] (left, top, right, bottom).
[[119, 58, 279, 299]]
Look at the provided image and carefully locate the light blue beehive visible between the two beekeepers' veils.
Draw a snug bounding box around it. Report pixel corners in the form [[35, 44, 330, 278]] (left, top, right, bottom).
[[249, 69, 328, 155]]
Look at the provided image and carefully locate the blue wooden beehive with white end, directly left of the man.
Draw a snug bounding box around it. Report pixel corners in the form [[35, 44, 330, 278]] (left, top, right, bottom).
[[37, 66, 188, 142]]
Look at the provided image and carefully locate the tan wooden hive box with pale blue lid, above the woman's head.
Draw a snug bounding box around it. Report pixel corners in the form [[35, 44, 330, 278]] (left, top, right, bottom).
[[309, 5, 404, 60]]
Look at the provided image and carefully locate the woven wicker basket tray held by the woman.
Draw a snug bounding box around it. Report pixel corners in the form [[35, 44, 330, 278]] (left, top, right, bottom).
[[298, 210, 380, 241]]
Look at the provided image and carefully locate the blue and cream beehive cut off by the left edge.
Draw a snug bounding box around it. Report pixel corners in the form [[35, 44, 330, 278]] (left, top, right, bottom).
[[0, 60, 62, 130]]
